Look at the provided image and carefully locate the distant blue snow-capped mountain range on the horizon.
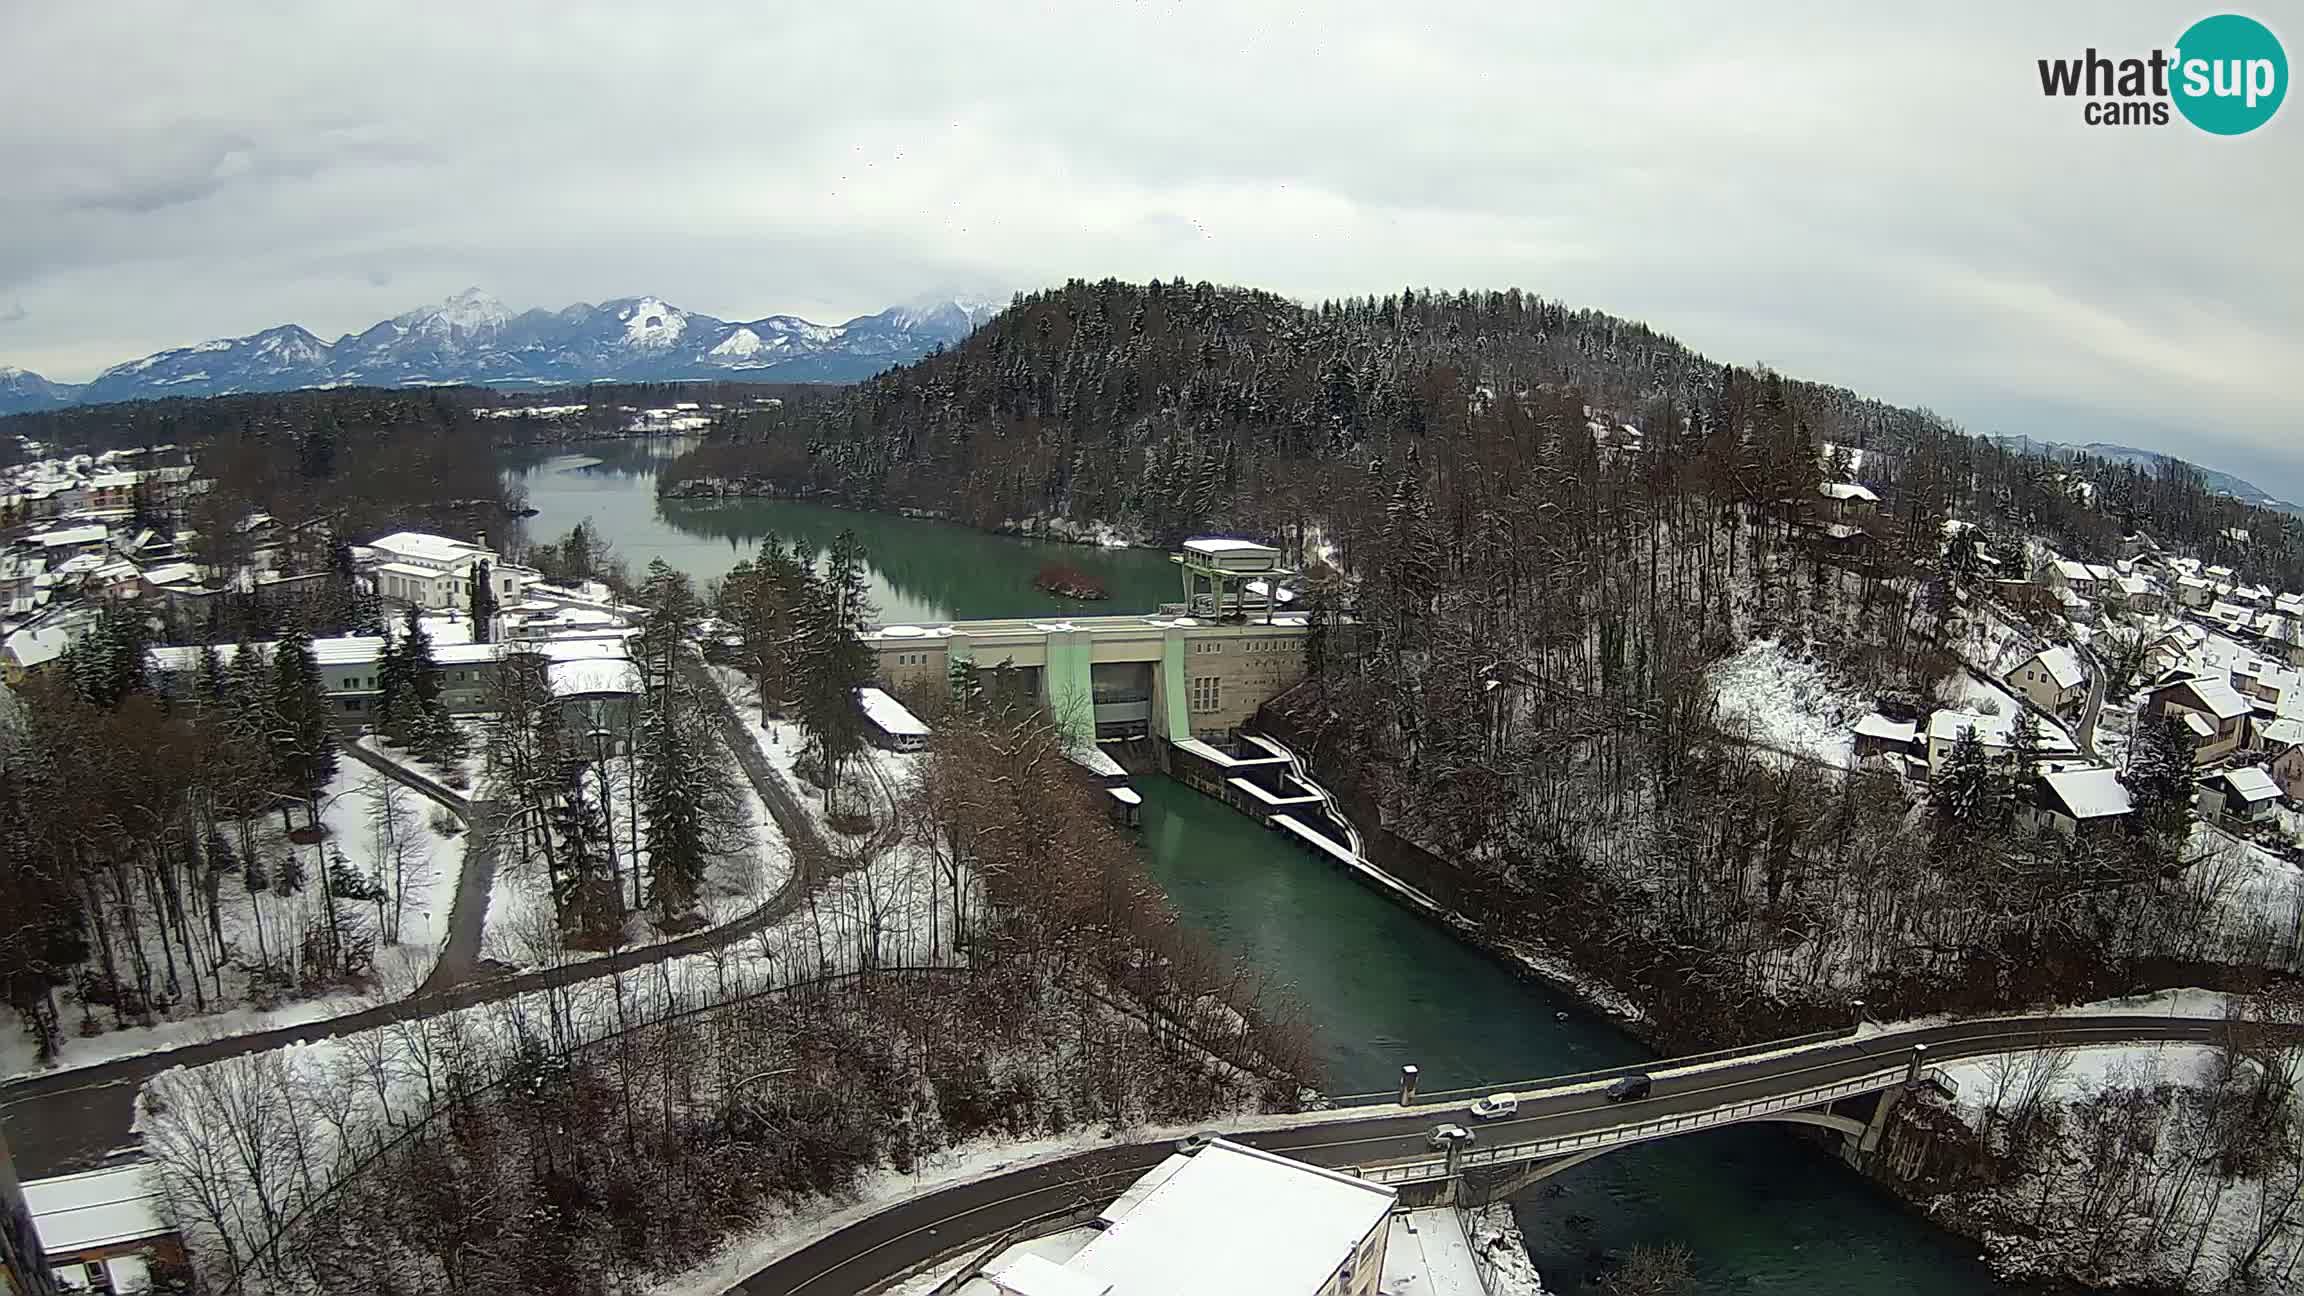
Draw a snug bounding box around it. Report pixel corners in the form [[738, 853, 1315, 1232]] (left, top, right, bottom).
[[0, 288, 1002, 415]]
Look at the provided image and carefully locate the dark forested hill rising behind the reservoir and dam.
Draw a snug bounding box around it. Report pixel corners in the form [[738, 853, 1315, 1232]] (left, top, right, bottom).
[[666, 279, 2304, 574]]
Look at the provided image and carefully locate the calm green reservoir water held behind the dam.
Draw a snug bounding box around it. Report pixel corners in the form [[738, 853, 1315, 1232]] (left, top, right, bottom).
[[502, 438, 1182, 623]]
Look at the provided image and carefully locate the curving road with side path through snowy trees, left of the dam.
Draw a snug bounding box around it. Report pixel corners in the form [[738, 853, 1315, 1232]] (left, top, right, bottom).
[[0, 664, 841, 1178]]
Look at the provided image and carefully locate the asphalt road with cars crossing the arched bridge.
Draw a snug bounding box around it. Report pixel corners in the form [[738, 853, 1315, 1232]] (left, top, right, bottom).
[[737, 1017, 2226, 1296]]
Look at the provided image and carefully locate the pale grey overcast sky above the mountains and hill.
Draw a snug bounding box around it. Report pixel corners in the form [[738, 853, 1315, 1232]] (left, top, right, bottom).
[[0, 0, 2304, 488]]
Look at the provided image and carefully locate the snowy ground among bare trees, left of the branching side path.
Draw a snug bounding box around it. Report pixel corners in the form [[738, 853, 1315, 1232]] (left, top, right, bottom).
[[0, 759, 465, 1075]]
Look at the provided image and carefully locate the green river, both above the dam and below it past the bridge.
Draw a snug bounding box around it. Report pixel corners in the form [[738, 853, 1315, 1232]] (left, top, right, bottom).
[[507, 440, 2016, 1296]]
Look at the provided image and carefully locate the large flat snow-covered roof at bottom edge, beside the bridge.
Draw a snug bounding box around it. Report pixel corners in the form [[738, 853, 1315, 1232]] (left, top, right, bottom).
[[1064, 1139, 1394, 1296]]
